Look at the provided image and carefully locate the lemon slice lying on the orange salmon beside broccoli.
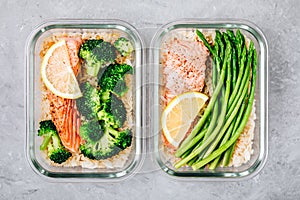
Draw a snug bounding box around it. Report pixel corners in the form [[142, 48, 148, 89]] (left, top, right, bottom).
[[41, 40, 82, 99]]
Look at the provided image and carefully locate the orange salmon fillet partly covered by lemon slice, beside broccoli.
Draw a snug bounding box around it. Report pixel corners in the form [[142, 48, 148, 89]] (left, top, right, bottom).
[[47, 38, 82, 152]]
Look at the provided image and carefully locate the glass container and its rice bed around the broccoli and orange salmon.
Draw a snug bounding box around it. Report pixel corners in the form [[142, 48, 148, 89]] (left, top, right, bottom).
[[26, 20, 144, 181]]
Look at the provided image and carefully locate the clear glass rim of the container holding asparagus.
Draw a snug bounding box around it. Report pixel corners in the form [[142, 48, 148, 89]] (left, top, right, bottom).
[[149, 18, 269, 181]]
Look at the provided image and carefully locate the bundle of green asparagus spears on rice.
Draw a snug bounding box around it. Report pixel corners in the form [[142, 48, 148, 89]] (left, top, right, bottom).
[[175, 30, 256, 169]]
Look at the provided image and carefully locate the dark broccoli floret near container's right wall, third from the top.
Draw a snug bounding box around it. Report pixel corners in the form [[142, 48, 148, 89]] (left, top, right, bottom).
[[98, 64, 133, 96]]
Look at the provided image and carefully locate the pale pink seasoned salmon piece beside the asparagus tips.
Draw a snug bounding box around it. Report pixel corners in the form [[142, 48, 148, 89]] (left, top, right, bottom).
[[162, 38, 209, 105]]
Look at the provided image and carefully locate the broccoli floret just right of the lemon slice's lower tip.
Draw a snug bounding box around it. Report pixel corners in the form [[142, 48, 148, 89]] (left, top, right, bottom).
[[76, 82, 101, 120]]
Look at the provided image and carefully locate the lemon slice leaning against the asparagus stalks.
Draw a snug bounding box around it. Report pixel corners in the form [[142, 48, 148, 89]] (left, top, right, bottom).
[[161, 92, 208, 147]]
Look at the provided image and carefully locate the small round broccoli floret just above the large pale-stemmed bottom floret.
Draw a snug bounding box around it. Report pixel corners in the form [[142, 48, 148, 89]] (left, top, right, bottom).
[[80, 120, 104, 143]]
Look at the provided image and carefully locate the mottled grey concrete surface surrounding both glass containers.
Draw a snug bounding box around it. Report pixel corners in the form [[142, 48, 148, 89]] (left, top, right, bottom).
[[0, 0, 300, 200]]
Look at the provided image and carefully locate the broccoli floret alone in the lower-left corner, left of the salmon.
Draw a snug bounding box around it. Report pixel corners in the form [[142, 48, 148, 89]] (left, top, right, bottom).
[[38, 120, 72, 164]]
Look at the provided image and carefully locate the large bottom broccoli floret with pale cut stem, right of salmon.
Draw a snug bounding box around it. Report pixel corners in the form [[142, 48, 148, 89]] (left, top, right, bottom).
[[80, 128, 132, 160]]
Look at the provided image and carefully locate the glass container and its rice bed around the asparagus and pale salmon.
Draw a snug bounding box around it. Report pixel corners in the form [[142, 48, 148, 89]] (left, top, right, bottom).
[[149, 19, 268, 180]]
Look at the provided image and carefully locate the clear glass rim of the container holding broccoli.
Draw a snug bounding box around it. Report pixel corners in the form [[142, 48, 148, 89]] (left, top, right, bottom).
[[24, 18, 146, 182]]
